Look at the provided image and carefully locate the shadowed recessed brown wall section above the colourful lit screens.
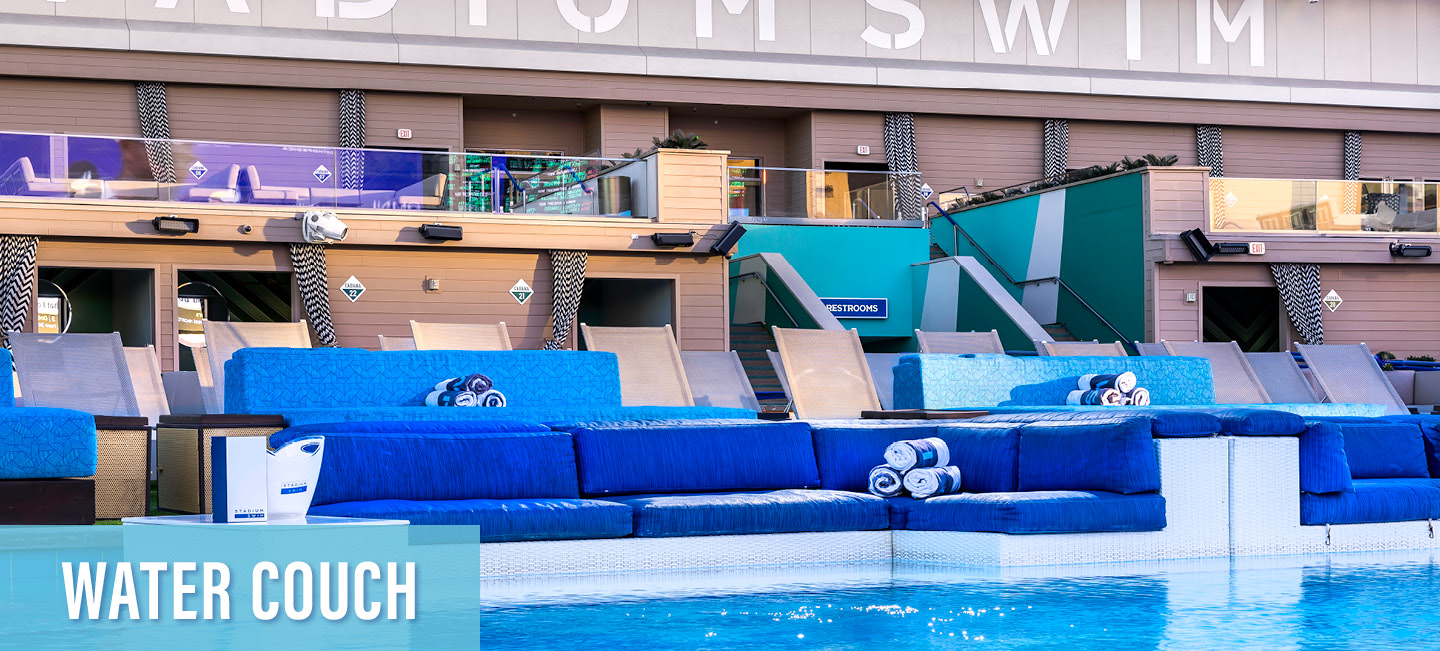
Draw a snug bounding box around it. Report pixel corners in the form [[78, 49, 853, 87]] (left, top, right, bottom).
[[465, 108, 598, 156]]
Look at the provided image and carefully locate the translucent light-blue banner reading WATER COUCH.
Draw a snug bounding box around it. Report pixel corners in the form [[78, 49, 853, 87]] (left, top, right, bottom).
[[0, 524, 481, 651]]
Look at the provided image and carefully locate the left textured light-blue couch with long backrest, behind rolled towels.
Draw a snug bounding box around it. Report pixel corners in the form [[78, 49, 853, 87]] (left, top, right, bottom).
[[225, 349, 755, 425]]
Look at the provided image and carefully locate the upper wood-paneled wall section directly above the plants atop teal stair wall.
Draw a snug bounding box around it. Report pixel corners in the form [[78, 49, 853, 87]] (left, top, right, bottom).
[[1068, 120, 1198, 169]]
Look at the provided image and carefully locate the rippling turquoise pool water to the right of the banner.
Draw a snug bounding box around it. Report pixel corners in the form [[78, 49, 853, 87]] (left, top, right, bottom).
[[480, 553, 1440, 651]]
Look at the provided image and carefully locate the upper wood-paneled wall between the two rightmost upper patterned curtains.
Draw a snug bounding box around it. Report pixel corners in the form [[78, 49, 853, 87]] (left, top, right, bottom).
[[1224, 127, 1345, 179]]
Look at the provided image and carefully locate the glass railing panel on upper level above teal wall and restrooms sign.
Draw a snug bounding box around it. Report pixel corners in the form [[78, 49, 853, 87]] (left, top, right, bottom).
[[729, 166, 920, 219]]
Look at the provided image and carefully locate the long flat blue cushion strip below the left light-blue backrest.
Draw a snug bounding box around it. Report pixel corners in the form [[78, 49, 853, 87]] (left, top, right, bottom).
[[276, 406, 756, 431]]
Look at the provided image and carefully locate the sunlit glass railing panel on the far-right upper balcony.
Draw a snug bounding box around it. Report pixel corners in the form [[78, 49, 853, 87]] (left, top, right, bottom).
[[1210, 179, 1436, 233]]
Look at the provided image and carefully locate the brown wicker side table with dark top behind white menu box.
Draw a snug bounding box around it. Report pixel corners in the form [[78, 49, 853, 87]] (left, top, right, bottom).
[[156, 413, 285, 513]]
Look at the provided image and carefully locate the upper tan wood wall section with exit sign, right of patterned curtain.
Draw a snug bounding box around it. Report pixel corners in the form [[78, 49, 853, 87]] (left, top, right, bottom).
[[365, 92, 465, 151]]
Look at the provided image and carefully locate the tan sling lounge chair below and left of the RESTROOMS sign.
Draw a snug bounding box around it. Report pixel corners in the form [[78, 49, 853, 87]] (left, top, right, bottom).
[[773, 328, 881, 419]]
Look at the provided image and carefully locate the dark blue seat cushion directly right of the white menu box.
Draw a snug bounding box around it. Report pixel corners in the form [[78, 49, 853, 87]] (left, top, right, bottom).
[[310, 500, 631, 543]]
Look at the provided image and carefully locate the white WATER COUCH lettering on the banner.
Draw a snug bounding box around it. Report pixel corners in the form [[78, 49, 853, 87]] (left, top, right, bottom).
[[60, 560, 419, 621]]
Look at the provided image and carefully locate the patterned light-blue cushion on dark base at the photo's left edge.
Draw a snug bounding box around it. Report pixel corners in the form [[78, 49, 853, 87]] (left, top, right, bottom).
[[0, 406, 98, 480]]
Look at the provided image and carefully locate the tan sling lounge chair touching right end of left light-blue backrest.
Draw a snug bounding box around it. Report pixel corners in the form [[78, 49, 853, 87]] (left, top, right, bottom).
[[580, 323, 696, 406]]
